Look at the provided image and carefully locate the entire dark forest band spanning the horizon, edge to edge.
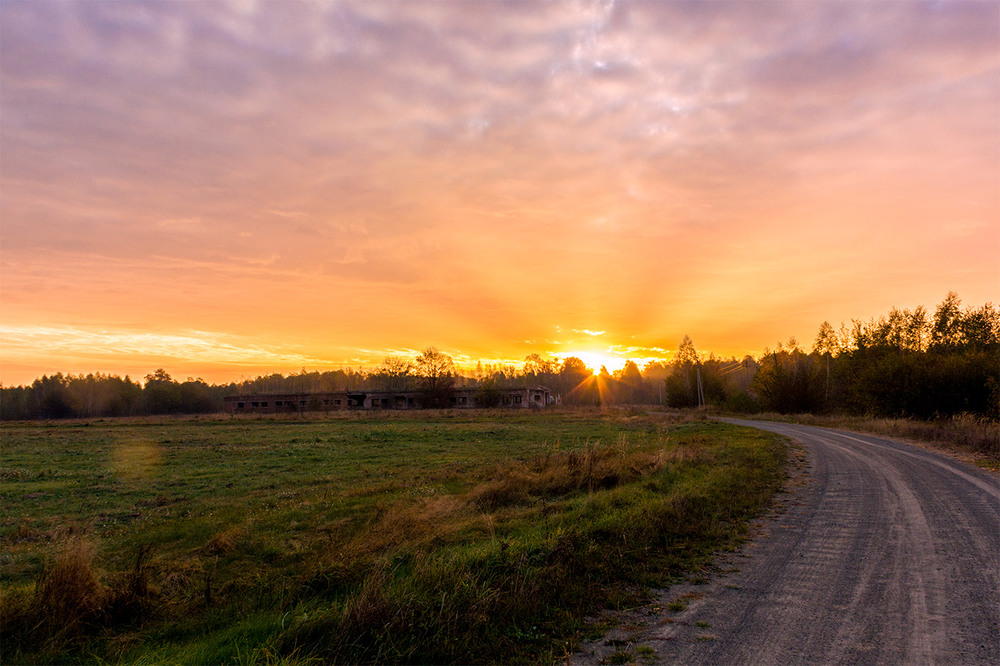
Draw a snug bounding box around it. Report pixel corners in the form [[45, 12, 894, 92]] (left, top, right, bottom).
[[0, 292, 1000, 420]]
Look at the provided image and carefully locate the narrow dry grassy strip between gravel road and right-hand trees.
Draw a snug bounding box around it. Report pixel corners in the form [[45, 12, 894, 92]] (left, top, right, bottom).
[[741, 413, 1000, 471]]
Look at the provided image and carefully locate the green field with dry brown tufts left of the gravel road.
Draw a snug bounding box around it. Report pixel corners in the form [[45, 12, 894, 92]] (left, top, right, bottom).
[[0, 410, 785, 664]]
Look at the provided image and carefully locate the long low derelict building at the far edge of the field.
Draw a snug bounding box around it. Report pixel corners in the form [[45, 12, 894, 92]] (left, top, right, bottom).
[[222, 386, 556, 414]]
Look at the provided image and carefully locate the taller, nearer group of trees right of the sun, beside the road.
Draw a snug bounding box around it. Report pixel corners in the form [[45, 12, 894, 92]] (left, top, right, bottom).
[[666, 292, 1000, 420]]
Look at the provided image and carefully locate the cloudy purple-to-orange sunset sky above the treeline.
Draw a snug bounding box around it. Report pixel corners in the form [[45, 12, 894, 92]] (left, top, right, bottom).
[[0, 0, 1000, 385]]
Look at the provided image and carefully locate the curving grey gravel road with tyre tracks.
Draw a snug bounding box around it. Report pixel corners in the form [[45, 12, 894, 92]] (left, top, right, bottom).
[[571, 419, 1000, 664]]
